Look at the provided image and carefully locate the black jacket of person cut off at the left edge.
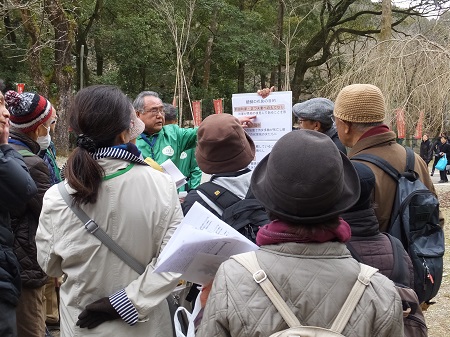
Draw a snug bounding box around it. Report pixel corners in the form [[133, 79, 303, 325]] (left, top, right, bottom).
[[0, 144, 37, 306]]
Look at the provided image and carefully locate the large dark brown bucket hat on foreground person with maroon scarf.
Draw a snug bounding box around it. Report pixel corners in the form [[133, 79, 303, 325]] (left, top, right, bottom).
[[251, 130, 360, 224]]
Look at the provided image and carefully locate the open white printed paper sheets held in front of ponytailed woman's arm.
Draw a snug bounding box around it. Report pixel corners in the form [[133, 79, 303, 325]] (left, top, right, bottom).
[[154, 202, 258, 285]]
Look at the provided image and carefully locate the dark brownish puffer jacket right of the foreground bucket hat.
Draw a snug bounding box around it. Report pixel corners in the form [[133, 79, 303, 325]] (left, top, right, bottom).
[[341, 208, 414, 288]]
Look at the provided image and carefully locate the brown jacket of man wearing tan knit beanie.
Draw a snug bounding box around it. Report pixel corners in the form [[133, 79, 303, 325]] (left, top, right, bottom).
[[348, 131, 444, 232]]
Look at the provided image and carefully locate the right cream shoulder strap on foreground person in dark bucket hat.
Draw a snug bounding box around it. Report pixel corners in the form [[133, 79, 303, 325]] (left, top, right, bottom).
[[330, 263, 378, 333]]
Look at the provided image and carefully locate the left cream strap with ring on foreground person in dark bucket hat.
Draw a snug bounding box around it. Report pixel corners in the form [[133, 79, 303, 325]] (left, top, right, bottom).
[[231, 252, 302, 328]]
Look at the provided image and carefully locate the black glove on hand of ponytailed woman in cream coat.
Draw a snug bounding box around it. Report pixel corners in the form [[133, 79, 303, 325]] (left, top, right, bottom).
[[77, 297, 121, 329]]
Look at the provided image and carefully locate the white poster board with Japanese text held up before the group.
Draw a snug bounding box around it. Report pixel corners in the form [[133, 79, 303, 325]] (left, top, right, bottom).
[[232, 91, 292, 141]]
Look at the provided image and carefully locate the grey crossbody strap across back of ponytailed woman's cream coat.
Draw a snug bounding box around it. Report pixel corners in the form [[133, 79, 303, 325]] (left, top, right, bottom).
[[58, 181, 145, 275]]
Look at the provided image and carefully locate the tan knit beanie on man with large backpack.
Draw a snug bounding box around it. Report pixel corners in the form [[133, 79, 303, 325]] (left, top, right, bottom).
[[334, 84, 385, 123]]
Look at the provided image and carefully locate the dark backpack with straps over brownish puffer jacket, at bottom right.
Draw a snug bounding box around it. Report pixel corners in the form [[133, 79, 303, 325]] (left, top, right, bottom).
[[347, 233, 428, 337]]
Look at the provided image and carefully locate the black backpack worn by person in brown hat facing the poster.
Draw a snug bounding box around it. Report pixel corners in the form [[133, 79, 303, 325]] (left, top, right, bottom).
[[197, 182, 270, 242]]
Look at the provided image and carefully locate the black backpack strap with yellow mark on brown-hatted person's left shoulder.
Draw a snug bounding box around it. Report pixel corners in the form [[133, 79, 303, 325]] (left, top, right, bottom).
[[196, 181, 241, 216]]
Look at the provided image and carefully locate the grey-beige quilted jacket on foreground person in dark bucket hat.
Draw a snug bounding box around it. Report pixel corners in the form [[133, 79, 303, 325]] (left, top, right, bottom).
[[196, 242, 403, 337]]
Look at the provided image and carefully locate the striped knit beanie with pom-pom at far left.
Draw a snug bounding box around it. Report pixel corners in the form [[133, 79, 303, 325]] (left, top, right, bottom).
[[5, 90, 52, 133]]
